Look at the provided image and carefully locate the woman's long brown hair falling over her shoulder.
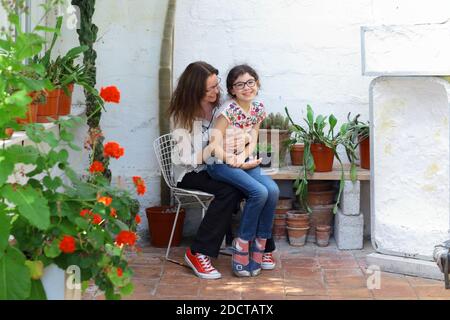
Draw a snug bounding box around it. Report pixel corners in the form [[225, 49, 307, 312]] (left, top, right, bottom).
[[169, 61, 220, 132]]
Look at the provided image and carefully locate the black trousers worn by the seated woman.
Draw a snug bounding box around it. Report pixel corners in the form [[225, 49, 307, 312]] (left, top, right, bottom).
[[178, 170, 275, 257]]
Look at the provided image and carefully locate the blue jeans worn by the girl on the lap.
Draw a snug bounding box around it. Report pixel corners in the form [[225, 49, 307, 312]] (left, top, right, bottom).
[[207, 163, 280, 241]]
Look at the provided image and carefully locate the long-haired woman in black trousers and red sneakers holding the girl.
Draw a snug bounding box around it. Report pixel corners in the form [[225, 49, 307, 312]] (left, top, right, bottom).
[[169, 61, 275, 279]]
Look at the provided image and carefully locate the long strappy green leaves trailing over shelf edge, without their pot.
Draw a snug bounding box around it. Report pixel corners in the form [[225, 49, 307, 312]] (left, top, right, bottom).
[[285, 105, 356, 213]]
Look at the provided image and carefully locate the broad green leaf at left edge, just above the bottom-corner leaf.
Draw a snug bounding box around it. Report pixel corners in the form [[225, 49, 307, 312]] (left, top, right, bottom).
[[1, 185, 50, 230]]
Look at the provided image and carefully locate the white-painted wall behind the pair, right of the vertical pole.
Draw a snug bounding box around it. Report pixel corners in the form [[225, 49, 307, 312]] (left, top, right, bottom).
[[174, 0, 450, 141]]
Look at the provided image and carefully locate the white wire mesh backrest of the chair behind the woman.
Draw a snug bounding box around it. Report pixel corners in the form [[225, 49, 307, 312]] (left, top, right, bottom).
[[153, 133, 176, 188]]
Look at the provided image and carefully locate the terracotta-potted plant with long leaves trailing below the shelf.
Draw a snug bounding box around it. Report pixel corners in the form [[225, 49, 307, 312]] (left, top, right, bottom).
[[285, 105, 356, 213]]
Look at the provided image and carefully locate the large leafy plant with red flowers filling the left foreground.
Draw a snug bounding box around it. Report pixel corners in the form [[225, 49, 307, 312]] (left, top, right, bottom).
[[0, 2, 146, 300]]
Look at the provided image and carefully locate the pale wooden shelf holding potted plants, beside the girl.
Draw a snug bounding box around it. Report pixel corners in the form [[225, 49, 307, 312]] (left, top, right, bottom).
[[263, 164, 370, 181]]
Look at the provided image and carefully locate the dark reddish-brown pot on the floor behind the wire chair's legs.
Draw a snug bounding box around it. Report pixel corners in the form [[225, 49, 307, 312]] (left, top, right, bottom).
[[145, 206, 185, 248]]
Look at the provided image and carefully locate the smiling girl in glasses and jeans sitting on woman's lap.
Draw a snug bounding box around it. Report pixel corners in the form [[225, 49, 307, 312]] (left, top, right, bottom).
[[207, 65, 279, 277]]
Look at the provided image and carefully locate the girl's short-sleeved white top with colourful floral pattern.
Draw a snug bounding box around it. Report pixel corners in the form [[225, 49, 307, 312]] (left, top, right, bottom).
[[219, 100, 266, 131]]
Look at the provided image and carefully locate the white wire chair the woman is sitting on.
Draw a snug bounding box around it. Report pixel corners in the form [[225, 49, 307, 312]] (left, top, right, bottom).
[[153, 133, 214, 265]]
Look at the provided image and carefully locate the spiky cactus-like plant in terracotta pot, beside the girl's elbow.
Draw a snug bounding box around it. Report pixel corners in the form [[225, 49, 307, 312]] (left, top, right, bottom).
[[259, 112, 292, 164]]
